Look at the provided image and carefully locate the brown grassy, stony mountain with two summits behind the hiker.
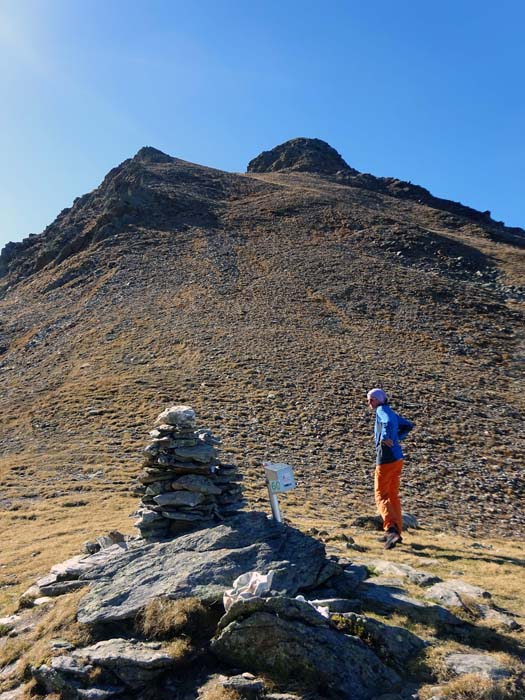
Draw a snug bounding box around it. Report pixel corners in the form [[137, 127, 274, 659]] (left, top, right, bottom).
[[0, 140, 525, 585]]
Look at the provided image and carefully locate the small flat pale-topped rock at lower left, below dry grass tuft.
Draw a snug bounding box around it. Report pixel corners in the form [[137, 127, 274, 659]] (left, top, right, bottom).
[[73, 639, 175, 688]]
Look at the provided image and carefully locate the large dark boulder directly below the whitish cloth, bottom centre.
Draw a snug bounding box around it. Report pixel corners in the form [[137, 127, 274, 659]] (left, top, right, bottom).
[[211, 598, 399, 700]]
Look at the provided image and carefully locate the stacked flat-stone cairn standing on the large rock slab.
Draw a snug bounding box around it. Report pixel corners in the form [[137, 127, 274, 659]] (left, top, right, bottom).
[[135, 406, 244, 540]]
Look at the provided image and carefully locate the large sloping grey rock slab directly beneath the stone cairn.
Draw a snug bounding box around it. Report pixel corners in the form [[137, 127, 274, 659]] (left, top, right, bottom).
[[78, 512, 326, 624]]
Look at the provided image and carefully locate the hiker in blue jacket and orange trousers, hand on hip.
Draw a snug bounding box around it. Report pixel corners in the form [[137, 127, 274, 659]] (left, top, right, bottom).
[[367, 389, 414, 549]]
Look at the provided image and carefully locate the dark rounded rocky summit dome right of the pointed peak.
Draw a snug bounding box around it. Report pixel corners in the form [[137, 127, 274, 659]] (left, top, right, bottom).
[[247, 137, 357, 175]]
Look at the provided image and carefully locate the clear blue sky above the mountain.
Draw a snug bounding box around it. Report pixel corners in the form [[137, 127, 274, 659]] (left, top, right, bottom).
[[0, 0, 525, 252]]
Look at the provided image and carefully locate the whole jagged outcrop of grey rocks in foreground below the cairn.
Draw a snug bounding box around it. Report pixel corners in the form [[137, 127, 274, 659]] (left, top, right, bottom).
[[10, 508, 513, 700]]
